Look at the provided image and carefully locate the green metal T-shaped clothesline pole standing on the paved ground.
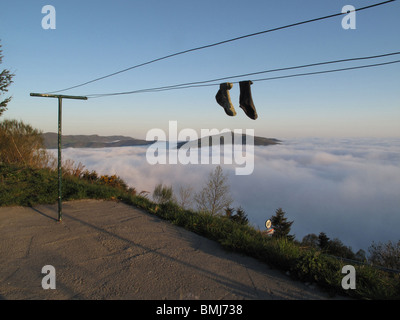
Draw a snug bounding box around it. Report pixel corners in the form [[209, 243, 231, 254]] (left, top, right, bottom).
[[30, 93, 87, 221]]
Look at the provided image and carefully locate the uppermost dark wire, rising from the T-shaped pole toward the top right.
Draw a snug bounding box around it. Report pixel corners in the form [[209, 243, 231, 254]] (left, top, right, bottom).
[[49, 0, 396, 93]]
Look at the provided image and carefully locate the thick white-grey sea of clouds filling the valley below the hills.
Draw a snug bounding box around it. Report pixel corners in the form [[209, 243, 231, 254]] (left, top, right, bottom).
[[57, 138, 400, 252]]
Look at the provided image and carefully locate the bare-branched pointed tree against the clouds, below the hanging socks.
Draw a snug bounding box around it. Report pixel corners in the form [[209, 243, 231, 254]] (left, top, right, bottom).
[[194, 166, 233, 215]]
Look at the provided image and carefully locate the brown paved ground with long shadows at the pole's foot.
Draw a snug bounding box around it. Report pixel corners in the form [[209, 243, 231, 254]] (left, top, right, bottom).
[[0, 200, 346, 300]]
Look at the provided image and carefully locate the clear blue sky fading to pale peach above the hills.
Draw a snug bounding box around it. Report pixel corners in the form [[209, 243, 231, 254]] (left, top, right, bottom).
[[0, 0, 400, 139]]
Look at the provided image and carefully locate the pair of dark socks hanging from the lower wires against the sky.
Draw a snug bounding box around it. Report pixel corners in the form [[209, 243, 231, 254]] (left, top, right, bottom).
[[215, 81, 258, 120]]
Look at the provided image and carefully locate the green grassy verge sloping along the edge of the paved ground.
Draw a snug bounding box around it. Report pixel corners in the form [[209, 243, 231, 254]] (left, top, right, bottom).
[[0, 164, 400, 299]]
